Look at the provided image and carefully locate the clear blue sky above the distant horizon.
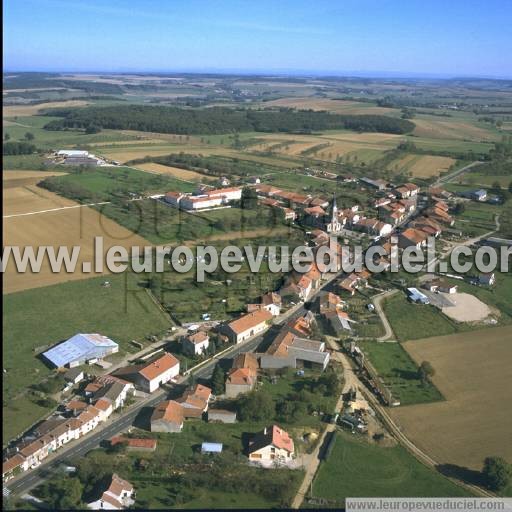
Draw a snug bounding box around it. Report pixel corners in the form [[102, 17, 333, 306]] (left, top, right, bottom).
[[3, 0, 512, 77]]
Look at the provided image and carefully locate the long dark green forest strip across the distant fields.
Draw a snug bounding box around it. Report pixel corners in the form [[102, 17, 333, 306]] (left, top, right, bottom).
[[45, 105, 415, 135]]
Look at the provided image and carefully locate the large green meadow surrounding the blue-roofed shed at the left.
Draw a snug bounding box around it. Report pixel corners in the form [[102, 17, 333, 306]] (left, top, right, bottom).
[[3, 274, 170, 438]]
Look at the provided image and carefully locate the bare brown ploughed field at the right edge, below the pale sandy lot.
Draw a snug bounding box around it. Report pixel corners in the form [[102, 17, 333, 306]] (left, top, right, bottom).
[[390, 326, 512, 470]]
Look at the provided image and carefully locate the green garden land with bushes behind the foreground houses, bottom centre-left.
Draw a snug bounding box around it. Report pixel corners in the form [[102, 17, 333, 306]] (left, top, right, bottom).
[[71, 420, 303, 509]]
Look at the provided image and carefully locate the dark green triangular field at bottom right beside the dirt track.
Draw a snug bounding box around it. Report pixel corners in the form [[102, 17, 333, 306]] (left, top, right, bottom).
[[313, 433, 469, 505]]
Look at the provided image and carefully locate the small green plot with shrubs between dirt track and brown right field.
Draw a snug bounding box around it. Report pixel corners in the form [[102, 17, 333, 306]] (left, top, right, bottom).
[[361, 341, 443, 405]]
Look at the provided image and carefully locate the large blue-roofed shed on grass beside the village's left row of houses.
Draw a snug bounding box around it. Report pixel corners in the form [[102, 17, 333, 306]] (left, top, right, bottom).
[[43, 334, 119, 368]]
